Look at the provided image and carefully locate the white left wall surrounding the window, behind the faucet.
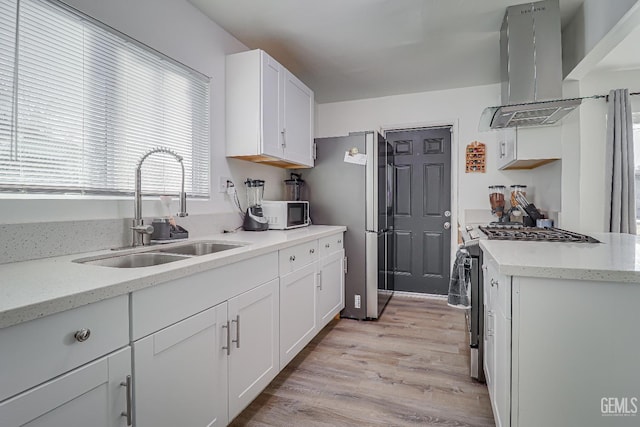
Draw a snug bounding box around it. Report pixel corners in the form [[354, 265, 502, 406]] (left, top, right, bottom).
[[0, 0, 285, 224]]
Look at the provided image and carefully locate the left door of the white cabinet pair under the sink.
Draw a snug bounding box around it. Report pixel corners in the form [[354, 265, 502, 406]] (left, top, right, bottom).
[[133, 303, 228, 427]]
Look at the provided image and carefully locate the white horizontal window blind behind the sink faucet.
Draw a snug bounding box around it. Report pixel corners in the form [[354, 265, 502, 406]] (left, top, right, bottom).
[[0, 0, 209, 197]]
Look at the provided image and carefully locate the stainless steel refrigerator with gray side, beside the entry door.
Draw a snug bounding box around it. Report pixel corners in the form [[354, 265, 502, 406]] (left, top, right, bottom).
[[303, 131, 394, 319]]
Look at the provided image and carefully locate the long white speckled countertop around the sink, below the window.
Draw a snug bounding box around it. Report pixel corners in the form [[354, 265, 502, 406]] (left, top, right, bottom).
[[0, 225, 346, 328]]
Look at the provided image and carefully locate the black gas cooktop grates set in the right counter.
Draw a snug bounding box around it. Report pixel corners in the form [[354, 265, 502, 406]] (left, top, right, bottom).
[[480, 224, 600, 243]]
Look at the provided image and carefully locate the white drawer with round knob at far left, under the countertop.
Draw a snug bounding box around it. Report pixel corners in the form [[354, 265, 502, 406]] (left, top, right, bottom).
[[0, 295, 129, 401]]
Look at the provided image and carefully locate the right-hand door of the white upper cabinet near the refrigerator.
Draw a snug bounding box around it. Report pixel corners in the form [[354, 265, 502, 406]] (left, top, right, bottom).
[[283, 70, 314, 166]]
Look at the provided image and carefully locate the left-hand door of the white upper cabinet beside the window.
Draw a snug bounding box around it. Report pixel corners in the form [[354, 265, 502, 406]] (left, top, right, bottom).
[[260, 52, 284, 158]]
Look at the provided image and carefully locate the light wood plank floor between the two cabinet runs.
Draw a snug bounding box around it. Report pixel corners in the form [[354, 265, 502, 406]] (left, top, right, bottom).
[[232, 296, 494, 427]]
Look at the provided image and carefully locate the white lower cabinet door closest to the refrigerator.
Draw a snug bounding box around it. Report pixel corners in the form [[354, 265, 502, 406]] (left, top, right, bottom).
[[318, 250, 344, 329]]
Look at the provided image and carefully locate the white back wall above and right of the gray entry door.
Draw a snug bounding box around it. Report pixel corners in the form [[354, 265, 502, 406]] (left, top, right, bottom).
[[316, 84, 561, 226]]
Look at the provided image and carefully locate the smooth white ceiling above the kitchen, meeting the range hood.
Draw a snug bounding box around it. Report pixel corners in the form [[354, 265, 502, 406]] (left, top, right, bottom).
[[189, 0, 584, 104]]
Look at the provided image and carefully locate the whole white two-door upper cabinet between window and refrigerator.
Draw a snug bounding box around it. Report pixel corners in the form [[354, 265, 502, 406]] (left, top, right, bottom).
[[226, 49, 314, 168]]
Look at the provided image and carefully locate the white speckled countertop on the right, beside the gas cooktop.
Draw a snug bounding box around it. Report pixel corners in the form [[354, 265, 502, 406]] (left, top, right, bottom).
[[480, 233, 640, 283]]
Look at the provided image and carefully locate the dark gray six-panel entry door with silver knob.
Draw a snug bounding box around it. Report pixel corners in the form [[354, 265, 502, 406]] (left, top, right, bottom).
[[386, 127, 451, 295]]
